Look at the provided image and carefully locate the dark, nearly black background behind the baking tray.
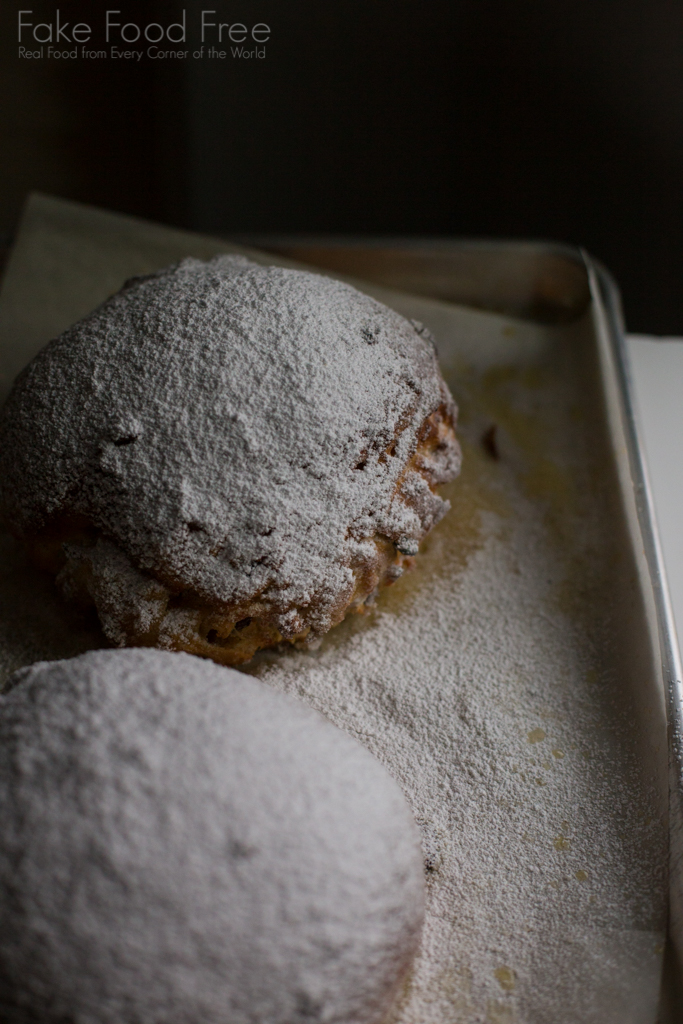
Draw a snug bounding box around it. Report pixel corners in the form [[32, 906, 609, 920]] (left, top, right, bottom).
[[0, 0, 683, 334]]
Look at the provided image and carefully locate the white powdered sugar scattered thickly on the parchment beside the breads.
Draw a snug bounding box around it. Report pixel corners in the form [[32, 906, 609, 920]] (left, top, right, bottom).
[[250, 507, 661, 1024]]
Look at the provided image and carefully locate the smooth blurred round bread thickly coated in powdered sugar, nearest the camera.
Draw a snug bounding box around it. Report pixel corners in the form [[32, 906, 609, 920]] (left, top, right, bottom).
[[0, 650, 424, 1024]]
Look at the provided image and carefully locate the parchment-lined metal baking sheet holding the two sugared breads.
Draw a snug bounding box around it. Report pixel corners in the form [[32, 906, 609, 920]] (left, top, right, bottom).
[[0, 197, 675, 1024]]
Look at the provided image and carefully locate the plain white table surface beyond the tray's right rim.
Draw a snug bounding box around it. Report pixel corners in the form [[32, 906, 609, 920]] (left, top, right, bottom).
[[627, 335, 683, 659]]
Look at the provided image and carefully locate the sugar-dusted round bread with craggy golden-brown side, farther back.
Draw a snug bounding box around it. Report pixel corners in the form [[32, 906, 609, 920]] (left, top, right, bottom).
[[0, 256, 460, 664]]
